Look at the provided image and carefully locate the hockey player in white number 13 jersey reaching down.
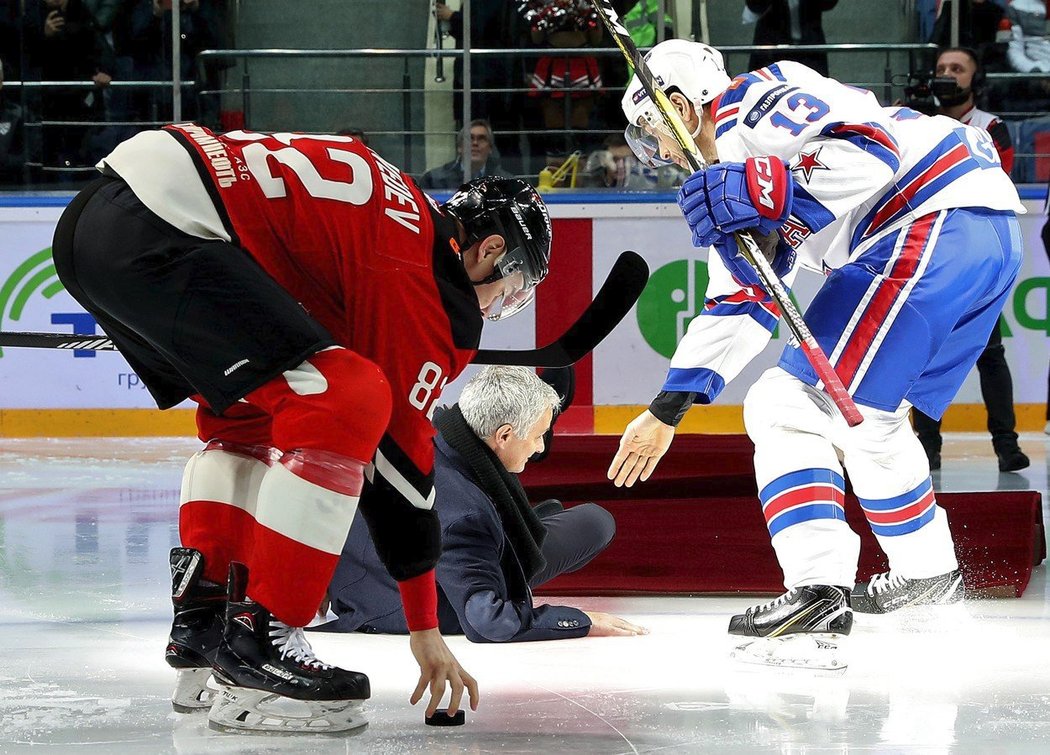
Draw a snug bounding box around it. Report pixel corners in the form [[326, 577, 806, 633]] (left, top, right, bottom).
[[609, 40, 1024, 667]]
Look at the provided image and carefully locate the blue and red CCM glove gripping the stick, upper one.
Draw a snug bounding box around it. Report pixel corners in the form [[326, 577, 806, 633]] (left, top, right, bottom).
[[678, 156, 795, 247]]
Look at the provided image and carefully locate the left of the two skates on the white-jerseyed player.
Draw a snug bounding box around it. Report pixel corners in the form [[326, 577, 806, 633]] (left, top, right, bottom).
[[729, 585, 853, 671]]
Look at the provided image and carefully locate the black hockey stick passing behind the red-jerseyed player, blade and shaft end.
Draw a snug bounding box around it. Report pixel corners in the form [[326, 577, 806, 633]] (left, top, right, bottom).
[[0, 252, 649, 368]]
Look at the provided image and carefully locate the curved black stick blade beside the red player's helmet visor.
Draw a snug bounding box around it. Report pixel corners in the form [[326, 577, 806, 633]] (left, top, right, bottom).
[[474, 251, 649, 368]]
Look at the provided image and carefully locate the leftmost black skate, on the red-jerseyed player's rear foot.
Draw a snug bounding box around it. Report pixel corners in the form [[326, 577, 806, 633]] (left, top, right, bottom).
[[164, 548, 226, 713]]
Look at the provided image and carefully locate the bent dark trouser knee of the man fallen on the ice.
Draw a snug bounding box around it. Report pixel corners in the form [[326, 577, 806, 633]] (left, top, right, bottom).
[[529, 503, 616, 587]]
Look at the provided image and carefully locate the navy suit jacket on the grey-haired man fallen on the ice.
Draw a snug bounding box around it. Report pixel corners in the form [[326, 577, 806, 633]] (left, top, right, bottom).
[[320, 436, 590, 643]]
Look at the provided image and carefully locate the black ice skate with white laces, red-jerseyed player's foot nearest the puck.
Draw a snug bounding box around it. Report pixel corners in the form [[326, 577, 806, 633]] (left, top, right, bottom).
[[208, 563, 371, 732]]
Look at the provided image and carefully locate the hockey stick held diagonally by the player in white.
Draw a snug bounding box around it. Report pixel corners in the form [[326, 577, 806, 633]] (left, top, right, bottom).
[[590, 0, 863, 427]]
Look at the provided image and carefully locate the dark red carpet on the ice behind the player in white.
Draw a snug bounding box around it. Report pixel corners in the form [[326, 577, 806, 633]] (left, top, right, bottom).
[[522, 435, 1046, 596]]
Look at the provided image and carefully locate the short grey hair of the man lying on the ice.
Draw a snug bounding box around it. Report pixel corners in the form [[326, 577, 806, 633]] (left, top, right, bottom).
[[459, 365, 561, 438]]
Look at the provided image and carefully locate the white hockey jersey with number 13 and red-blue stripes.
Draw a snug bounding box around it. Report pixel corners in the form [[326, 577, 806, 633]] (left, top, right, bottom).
[[664, 61, 1025, 403]]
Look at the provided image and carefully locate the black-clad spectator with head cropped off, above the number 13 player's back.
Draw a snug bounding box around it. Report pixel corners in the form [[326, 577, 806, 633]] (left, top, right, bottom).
[[743, 0, 838, 76]]
